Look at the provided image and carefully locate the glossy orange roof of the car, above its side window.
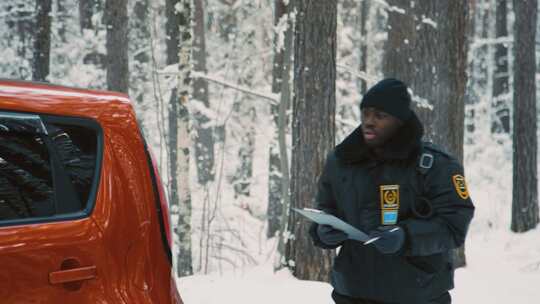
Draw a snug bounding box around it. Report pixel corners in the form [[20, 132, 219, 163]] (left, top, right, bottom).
[[0, 79, 131, 118]]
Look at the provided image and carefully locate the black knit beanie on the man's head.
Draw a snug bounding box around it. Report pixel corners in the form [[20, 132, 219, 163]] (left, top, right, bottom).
[[360, 78, 412, 121]]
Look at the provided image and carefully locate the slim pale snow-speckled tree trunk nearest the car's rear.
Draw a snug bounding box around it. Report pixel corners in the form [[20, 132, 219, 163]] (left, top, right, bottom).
[[165, 0, 193, 276]]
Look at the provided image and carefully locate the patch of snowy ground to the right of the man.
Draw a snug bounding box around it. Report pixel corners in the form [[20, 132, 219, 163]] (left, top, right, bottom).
[[454, 229, 540, 304]]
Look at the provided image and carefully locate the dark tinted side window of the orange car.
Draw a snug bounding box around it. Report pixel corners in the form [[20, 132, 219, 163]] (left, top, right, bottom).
[[0, 111, 99, 225]]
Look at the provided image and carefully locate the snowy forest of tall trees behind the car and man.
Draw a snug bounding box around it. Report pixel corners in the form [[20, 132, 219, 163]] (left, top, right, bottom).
[[0, 0, 540, 303]]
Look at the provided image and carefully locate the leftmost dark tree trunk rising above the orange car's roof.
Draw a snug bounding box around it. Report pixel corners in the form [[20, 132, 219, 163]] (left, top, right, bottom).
[[32, 0, 52, 81]]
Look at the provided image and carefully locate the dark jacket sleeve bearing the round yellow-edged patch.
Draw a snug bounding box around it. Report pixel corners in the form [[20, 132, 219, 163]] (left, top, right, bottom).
[[399, 156, 474, 256]]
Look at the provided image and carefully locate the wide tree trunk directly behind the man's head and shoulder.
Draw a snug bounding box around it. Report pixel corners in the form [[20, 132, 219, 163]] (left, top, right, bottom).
[[384, 0, 467, 267]]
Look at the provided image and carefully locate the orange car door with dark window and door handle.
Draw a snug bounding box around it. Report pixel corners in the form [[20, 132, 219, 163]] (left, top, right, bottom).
[[0, 109, 124, 303]]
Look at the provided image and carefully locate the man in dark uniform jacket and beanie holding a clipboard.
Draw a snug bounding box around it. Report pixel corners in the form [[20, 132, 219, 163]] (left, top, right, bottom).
[[310, 79, 474, 304]]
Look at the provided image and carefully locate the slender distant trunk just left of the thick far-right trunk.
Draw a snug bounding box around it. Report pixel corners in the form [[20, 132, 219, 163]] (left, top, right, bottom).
[[491, 0, 510, 133]]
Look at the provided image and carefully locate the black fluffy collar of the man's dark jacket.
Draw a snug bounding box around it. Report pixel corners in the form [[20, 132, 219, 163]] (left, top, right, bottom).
[[335, 113, 424, 163]]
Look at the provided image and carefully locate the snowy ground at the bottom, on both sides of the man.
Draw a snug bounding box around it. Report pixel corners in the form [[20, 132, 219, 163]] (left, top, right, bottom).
[[178, 229, 540, 304]]
